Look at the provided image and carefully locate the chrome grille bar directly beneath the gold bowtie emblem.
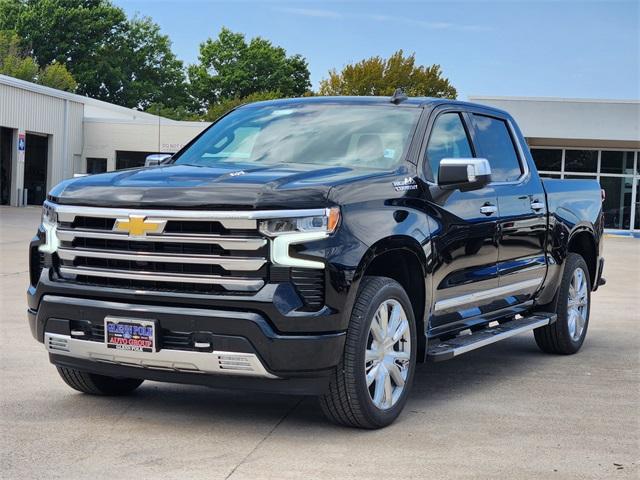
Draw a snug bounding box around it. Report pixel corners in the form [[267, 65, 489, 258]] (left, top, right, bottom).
[[58, 229, 267, 250]]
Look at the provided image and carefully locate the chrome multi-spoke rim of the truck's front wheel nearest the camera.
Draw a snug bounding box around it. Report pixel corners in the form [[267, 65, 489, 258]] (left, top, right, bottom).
[[364, 300, 411, 410]]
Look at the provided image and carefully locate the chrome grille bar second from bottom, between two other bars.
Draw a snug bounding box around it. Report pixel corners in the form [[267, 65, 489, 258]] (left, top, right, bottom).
[[58, 248, 267, 272]]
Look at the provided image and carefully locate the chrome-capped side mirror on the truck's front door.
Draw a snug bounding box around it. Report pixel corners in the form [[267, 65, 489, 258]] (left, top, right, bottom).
[[438, 158, 491, 191]]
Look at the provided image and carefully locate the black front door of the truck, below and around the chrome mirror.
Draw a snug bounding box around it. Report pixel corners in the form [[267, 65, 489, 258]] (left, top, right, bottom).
[[423, 106, 498, 328]]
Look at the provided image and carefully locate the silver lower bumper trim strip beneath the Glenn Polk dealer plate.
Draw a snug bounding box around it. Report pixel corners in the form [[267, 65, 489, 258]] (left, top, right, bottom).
[[44, 333, 278, 379]]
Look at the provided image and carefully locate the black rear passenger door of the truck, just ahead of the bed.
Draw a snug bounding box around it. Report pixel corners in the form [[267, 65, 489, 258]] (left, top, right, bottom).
[[470, 111, 547, 307]]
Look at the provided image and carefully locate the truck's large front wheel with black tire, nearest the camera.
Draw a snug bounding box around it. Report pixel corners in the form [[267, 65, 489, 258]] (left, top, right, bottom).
[[320, 277, 417, 429]]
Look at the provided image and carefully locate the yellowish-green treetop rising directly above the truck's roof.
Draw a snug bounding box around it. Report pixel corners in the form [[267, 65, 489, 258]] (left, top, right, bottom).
[[319, 50, 457, 98]]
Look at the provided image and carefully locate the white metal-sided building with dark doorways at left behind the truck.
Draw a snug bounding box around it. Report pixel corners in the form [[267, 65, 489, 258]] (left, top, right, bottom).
[[0, 75, 209, 205]]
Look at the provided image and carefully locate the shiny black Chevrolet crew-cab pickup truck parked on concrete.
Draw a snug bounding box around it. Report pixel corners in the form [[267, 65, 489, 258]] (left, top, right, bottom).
[[28, 94, 604, 428]]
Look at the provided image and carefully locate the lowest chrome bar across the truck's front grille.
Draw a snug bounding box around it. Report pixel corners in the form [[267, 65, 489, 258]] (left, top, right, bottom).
[[60, 267, 264, 292]]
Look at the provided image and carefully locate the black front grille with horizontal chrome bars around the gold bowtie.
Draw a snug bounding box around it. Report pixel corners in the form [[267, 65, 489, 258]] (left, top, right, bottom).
[[56, 206, 269, 295]]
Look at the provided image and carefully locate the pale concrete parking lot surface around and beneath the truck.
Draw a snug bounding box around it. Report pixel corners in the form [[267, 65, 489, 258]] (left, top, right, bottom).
[[0, 207, 640, 480]]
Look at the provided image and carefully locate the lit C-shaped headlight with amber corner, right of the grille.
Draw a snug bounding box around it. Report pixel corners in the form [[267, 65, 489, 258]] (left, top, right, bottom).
[[260, 207, 340, 269]]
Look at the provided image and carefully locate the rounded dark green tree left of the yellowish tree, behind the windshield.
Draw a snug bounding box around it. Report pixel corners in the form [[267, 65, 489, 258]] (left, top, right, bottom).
[[188, 28, 311, 109]]
